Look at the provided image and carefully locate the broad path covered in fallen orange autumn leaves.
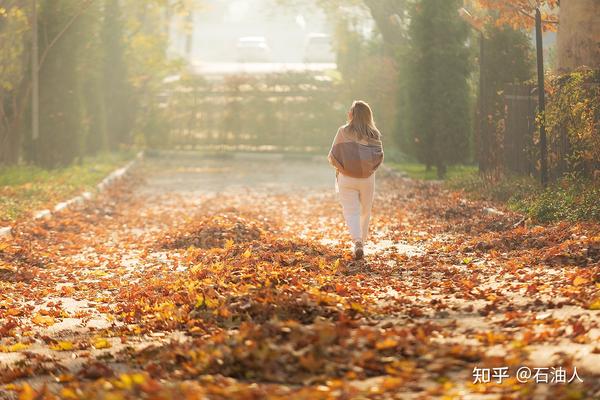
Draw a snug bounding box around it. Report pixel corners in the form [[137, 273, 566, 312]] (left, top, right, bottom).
[[0, 154, 600, 399]]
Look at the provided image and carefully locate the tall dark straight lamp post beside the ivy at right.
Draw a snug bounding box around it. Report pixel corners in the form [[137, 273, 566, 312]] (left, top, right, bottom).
[[529, 0, 548, 187]]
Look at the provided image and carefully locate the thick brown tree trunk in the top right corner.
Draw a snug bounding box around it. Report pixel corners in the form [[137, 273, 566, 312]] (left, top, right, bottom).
[[558, 0, 600, 72]]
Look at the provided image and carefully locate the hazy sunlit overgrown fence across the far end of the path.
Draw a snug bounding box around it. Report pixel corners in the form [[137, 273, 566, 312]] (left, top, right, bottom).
[[161, 73, 345, 151]]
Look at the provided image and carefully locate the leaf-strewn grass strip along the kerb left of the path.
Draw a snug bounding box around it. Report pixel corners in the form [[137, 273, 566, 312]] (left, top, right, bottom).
[[0, 152, 133, 225]]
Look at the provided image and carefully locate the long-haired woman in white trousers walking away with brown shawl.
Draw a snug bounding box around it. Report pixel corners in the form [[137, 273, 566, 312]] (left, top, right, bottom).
[[328, 100, 383, 260]]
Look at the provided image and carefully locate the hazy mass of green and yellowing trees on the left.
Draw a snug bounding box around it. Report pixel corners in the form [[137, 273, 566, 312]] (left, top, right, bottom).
[[0, 0, 188, 168]]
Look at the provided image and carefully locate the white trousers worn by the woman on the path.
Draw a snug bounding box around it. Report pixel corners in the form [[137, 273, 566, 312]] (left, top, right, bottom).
[[336, 174, 375, 243]]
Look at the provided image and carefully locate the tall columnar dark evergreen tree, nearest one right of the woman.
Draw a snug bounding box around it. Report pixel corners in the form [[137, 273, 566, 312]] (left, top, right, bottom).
[[408, 0, 470, 177]]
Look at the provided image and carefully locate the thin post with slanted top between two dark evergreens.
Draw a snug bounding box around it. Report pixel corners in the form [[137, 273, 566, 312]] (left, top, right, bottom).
[[458, 8, 490, 172]]
